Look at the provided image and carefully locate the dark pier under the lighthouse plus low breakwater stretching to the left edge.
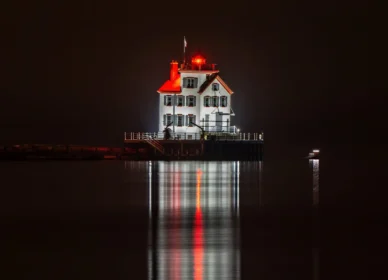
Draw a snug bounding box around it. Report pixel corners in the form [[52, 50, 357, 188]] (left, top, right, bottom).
[[0, 132, 264, 161]]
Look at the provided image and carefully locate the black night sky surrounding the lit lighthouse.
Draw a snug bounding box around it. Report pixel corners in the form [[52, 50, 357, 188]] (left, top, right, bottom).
[[0, 1, 368, 160]]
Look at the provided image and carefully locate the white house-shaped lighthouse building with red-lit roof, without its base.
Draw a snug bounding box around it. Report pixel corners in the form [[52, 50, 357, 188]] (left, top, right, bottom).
[[157, 55, 236, 137]]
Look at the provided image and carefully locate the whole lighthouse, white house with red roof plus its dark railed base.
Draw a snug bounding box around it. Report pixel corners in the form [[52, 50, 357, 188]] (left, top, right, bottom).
[[124, 50, 264, 160]]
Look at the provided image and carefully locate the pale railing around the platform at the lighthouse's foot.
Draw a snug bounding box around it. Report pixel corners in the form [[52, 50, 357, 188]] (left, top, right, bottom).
[[124, 132, 264, 140]]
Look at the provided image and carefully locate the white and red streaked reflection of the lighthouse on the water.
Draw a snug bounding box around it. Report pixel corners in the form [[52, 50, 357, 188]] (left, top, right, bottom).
[[148, 162, 240, 280]]
